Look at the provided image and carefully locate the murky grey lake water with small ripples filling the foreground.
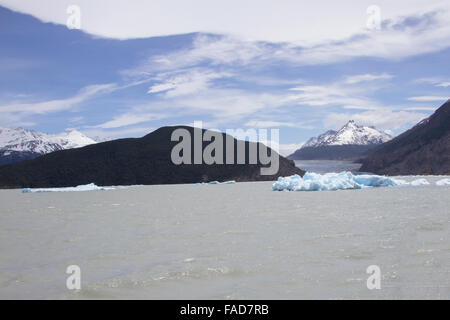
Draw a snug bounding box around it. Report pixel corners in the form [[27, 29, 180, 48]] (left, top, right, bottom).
[[0, 177, 450, 299]]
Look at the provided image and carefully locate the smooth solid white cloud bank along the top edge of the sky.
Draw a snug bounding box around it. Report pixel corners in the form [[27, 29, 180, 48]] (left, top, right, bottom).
[[0, 0, 449, 43]]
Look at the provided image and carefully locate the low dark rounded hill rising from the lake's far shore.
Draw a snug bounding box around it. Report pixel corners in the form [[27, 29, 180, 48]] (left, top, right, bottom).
[[0, 126, 304, 188]]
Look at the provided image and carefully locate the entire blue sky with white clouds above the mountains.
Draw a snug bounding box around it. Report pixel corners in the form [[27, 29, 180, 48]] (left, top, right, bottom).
[[0, 0, 450, 154]]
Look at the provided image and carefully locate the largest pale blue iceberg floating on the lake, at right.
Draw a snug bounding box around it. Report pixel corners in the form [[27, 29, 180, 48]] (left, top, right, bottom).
[[272, 172, 407, 191]]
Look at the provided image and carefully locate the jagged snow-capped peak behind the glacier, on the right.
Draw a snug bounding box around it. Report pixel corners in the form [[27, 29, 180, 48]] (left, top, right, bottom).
[[302, 120, 392, 148]]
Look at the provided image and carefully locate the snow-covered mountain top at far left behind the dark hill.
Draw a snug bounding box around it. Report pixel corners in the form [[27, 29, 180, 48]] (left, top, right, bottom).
[[0, 128, 96, 154]]
